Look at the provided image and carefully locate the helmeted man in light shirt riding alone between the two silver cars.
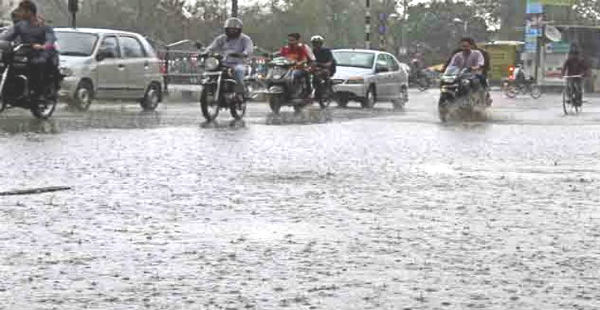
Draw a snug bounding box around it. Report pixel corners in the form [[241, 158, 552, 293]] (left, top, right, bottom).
[[206, 17, 254, 95]]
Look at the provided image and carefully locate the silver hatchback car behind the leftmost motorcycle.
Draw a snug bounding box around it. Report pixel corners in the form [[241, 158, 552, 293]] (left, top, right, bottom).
[[55, 28, 163, 110]]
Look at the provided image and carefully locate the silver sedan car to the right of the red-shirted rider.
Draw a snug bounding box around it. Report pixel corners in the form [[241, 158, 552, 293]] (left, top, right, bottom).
[[333, 49, 408, 108]]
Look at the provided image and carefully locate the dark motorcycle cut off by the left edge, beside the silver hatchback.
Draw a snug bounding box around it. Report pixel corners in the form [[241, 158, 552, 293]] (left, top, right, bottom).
[[0, 41, 63, 119]]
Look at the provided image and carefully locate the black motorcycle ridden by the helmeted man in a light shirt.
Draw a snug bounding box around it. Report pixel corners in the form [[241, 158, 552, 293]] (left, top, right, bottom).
[[200, 54, 246, 122]]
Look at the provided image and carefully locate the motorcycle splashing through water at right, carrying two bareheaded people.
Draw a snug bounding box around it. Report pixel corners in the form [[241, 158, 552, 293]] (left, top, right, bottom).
[[438, 66, 488, 122]]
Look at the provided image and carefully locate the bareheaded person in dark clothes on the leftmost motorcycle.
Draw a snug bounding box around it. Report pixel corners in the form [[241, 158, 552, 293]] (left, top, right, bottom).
[[0, 0, 58, 99]]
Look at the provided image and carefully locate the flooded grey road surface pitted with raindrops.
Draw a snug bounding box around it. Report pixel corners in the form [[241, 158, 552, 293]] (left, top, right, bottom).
[[0, 90, 600, 310]]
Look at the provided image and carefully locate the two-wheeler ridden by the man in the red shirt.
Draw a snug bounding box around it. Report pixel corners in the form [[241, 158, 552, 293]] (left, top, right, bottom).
[[266, 57, 312, 114]]
